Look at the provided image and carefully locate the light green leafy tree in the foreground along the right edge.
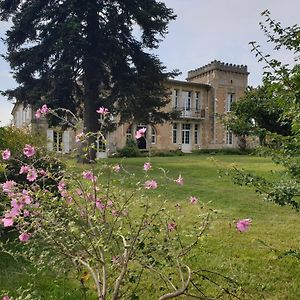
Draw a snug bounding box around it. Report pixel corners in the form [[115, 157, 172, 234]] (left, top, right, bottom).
[[226, 11, 300, 211]]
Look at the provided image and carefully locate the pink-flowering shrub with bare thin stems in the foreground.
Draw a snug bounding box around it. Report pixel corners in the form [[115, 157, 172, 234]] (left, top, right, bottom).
[[0, 108, 248, 300]]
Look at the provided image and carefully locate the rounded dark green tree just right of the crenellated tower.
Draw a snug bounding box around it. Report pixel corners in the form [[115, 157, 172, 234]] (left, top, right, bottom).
[[223, 80, 291, 148]]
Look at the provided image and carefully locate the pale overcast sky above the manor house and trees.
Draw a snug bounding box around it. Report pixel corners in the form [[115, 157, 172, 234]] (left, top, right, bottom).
[[0, 0, 300, 126]]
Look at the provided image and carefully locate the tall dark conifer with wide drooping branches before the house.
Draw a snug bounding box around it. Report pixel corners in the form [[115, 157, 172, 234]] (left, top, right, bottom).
[[0, 0, 175, 156]]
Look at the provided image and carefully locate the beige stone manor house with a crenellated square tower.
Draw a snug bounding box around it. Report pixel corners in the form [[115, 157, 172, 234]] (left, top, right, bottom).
[[12, 61, 249, 157]]
